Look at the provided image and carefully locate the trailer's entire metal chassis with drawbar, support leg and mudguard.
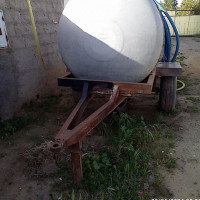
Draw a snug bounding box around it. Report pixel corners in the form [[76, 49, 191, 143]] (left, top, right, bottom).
[[51, 64, 181, 184]]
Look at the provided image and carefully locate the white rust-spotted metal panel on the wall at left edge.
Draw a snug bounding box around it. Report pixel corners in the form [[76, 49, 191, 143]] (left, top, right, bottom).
[[0, 10, 8, 48]]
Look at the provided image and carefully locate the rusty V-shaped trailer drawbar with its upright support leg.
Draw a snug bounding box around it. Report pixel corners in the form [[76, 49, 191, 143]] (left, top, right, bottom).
[[51, 85, 126, 184]]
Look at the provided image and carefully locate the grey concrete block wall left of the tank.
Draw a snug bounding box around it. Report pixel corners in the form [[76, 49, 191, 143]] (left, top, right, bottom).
[[0, 0, 66, 119]]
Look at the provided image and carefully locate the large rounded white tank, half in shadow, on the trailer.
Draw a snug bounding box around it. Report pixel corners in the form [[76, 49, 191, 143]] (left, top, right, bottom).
[[58, 0, 164, 82]]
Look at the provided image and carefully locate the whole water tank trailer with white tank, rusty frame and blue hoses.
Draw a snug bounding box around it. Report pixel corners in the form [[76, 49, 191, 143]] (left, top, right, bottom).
[[51, 0, 181, 183]]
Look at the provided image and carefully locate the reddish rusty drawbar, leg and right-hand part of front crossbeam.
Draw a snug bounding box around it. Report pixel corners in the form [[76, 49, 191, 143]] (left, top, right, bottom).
[[51, 69, 156, 184]]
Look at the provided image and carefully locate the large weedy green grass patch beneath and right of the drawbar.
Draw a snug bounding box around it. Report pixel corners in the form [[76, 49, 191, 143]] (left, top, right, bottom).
[[52, 113, 176, 200]]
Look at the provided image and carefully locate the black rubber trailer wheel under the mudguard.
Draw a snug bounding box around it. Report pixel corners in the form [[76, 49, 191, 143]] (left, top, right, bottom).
[[159, 76, 177, 112]]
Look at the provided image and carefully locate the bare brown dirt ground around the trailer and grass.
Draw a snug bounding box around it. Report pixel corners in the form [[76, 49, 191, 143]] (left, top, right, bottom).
[[0, 37, 200, 200]]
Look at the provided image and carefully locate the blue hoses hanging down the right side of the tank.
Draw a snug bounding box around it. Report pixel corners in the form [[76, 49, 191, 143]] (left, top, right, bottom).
[[153, 0, 180, 62]]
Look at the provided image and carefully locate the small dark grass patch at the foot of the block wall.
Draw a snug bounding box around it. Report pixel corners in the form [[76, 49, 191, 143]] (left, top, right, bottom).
[[0, 117, 33, 139]]
